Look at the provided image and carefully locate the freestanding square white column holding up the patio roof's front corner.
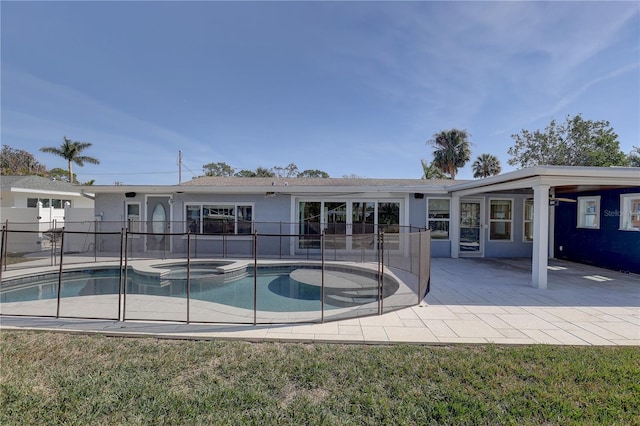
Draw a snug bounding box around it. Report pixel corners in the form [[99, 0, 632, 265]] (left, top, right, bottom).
[[531, 185, 549, 289]]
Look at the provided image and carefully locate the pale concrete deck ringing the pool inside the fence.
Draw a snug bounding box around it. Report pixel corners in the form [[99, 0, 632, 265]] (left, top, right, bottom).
[[0, 259, 419, 324]]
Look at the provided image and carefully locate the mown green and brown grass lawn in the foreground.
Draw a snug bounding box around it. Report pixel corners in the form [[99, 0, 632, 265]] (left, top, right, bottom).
[[0, 331, 640, 425]]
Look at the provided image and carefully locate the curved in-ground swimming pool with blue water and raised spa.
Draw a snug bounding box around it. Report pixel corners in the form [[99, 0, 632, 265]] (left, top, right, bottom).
[[0, 262, 398, 313]]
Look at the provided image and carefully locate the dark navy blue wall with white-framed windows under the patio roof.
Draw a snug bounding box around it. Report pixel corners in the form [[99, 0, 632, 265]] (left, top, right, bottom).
[[554, 188, 640, 273]]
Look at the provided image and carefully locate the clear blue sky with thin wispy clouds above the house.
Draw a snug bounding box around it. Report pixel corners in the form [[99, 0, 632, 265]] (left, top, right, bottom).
[[0, 1, 640, 185]]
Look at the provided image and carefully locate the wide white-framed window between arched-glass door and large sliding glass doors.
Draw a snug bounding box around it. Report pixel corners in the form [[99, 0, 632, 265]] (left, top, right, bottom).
[[185, 204, 253, 235]]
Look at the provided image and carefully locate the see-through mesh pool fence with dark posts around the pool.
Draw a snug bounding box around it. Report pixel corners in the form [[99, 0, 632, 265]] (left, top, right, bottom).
[[0, 222, 431, 325]]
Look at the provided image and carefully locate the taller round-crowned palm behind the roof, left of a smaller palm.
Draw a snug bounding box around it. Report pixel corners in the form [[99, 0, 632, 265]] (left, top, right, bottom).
[[428, 129, 471, 179]]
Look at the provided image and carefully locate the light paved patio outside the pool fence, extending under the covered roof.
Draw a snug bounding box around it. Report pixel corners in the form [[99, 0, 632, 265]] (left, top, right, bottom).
[[0, 258, 640, 346]]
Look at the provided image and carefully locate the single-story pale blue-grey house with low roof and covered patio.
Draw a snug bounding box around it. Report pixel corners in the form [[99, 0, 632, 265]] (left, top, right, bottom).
[[85, 166, 640, 288]]
